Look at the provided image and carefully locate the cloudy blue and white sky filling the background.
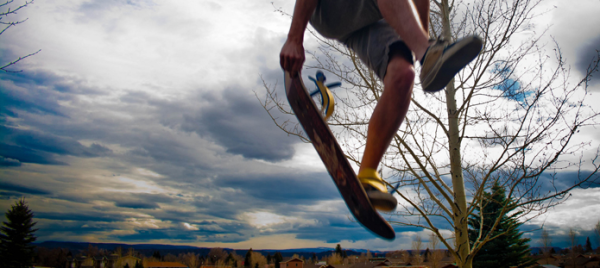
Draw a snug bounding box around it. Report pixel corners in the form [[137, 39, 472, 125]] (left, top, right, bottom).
[[0, 0, 600, 250]]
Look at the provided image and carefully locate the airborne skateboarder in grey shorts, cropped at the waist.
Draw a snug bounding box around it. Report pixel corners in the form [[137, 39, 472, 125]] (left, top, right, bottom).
[[280, 0, 482, 214]]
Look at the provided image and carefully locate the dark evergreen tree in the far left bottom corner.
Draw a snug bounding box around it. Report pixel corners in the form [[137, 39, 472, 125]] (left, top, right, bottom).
[[0, 198, 37, 268]]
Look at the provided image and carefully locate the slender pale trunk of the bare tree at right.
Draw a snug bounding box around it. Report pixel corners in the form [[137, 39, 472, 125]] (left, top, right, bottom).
[[442, 0, 473, 268]]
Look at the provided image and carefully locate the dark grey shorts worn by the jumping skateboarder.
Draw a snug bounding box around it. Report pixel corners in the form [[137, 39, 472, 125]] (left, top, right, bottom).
[[310, 0, 414, 80]]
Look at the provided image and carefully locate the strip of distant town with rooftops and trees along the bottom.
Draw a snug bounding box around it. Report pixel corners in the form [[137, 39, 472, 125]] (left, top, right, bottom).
[[34, 241, 600, 268]]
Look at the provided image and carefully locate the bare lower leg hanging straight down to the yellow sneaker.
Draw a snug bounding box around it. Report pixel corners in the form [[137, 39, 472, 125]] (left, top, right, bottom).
[[359, 54, 415, 173]]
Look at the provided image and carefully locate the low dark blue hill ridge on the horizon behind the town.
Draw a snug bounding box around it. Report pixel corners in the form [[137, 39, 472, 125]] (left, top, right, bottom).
[[34, 241, 385, 259]]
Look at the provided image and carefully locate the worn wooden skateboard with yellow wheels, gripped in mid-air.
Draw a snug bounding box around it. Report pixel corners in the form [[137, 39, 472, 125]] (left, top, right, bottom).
[[285, 72, 396, 240]]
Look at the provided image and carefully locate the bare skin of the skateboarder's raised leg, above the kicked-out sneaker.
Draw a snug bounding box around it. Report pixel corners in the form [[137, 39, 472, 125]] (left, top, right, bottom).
[[377, 0, 429, 60]]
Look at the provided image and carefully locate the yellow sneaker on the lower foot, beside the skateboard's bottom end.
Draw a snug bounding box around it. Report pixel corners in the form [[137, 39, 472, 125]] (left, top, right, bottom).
[[357, 168, 398, 212]]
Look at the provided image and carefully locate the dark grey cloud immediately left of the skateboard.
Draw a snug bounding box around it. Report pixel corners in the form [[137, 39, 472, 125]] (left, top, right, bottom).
[[182, 88, 297, 162]]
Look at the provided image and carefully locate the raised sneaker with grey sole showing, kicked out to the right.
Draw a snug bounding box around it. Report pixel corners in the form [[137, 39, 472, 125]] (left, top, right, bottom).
[[420, 36, 483, 93]]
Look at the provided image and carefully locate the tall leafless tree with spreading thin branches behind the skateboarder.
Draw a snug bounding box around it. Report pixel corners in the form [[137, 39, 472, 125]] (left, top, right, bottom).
[[257, 0, 600, 268]]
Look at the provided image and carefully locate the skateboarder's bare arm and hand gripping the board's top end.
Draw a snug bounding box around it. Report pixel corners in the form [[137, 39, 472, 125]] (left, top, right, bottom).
[[279, 0, 318, 77]]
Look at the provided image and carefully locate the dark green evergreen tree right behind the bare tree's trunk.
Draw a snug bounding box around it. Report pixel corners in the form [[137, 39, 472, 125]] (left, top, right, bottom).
[[469, 183, 535, 268]]
